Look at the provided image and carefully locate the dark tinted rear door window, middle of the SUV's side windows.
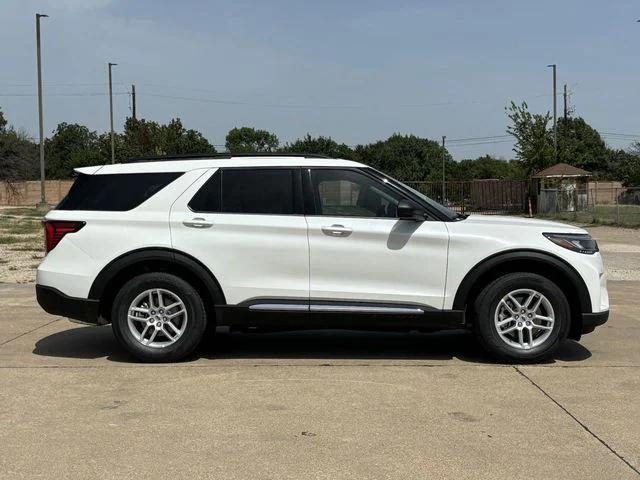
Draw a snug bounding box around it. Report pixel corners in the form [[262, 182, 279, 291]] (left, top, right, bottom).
[[189, 168, 302, 215]]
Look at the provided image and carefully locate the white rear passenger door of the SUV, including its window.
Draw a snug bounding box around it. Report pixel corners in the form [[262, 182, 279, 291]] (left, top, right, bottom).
[[170, 167, 309, 305]]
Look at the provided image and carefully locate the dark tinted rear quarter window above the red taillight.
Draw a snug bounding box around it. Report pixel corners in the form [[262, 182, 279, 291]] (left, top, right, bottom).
[[56, 172, 182, 212]]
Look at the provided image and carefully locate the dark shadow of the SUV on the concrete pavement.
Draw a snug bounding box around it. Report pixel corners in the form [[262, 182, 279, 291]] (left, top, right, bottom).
[[33, 326, 591, 364]]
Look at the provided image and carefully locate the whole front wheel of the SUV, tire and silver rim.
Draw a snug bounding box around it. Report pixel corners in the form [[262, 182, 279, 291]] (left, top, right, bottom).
[[474, 273, 571, 363]]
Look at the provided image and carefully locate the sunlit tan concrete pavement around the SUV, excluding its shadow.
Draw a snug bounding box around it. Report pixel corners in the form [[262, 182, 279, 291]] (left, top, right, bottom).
[[0, 281, 640, 479]]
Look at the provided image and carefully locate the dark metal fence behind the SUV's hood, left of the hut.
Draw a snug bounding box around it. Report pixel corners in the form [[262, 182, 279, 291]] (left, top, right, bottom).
[[404, 180, 529, 215]]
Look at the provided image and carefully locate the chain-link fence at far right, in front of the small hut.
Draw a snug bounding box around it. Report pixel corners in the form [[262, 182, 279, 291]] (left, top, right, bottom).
[[538, 186, 640, 227]]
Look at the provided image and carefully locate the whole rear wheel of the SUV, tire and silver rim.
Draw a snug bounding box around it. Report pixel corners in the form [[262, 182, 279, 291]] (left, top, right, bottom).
[[111, 272, 207, 362]]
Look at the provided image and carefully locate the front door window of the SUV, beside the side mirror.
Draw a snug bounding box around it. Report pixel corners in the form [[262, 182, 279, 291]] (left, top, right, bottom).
[[311, 169, 402, 218]]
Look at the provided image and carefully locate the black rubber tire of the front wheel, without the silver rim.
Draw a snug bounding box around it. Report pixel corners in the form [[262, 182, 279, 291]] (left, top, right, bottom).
[[475, 273, 571, 362]]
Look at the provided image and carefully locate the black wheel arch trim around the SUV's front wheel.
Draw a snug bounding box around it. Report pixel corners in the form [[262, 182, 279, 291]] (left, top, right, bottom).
[[453, 250, 592, 339]]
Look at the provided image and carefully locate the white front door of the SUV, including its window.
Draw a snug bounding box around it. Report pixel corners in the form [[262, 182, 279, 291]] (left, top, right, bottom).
[[303, 168, 449, 309]]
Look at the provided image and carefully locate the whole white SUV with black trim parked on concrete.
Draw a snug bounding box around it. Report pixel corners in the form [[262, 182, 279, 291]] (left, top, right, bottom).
[[36, 155, 609, 362]]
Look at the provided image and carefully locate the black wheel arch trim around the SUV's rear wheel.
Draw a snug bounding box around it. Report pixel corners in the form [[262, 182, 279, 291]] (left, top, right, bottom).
[[88, 247, 226, 322]]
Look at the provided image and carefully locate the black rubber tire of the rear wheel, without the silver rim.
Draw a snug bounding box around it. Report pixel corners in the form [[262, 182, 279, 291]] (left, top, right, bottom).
[[111, 273, 207, 362]]
